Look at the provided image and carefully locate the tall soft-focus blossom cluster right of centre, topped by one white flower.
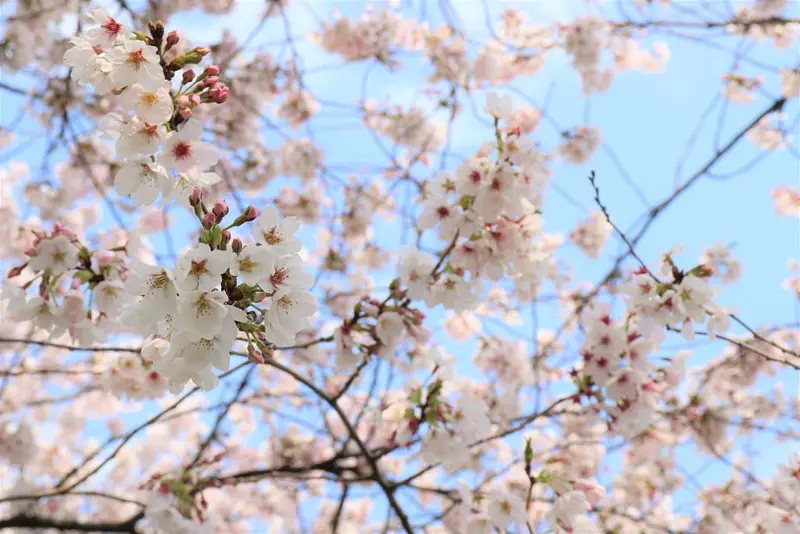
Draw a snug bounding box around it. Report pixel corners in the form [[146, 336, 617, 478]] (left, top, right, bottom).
[[390, 93, 549, 311]]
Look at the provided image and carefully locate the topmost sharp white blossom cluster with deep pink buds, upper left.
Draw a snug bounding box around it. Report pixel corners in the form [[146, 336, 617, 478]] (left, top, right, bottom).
[[64, 8, 229, 205]]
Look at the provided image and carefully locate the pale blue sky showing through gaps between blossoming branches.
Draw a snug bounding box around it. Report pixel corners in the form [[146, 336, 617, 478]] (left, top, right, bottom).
[[0, 0, 800, 532]]
